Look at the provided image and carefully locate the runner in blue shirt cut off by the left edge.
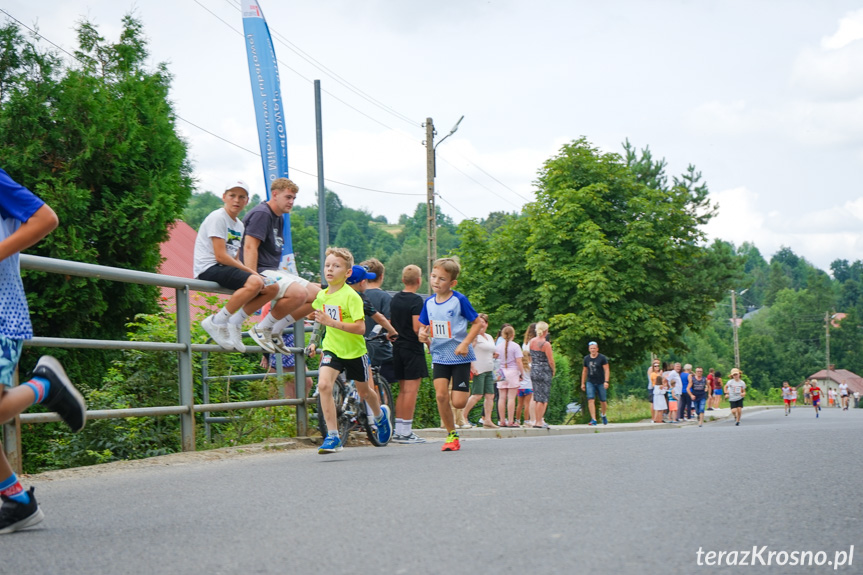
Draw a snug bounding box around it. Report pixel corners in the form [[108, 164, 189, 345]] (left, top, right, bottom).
[[0, 169, 87, 534]]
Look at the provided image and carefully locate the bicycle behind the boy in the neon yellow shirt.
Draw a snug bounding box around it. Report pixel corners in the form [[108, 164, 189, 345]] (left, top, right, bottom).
[[315, 334, 395, 447]]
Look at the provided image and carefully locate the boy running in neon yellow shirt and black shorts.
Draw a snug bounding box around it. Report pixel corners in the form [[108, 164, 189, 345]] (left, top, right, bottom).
[[308, 248, 392, 455]]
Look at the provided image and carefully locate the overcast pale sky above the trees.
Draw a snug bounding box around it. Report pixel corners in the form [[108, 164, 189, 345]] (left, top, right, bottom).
[[5, 0, 863, 269]]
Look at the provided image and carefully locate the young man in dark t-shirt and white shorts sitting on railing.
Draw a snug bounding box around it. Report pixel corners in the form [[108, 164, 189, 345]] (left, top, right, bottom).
[[240, 178, 321, 353]]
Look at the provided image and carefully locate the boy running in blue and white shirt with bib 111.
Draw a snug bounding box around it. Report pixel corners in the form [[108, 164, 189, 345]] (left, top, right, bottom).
[[419, 258, 481, 451]]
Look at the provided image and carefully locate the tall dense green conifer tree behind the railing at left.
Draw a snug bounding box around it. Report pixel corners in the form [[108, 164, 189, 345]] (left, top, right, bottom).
[[0, 16, 192, 388]]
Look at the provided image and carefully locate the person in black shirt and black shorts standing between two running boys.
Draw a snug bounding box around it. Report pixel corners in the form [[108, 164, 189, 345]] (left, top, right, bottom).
[[390, 265, 428, 444]]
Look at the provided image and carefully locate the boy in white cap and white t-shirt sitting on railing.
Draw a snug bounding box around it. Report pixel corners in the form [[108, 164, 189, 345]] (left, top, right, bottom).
[[193, 181, 279, 352]]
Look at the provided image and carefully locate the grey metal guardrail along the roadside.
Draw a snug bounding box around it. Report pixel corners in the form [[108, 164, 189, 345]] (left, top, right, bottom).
[[3, 254, 316, 473]]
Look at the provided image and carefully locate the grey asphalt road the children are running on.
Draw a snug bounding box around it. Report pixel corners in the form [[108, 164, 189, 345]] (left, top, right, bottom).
[[0, 407, 863, 575]]
